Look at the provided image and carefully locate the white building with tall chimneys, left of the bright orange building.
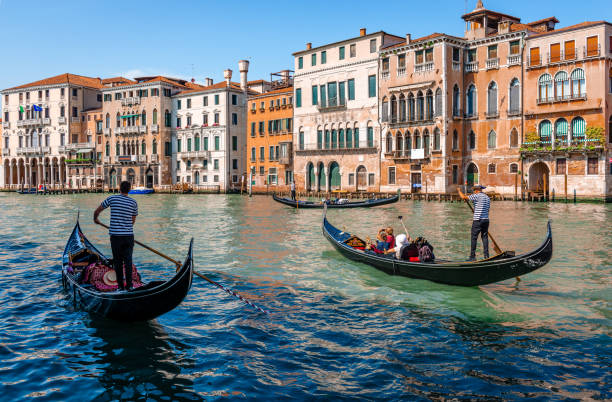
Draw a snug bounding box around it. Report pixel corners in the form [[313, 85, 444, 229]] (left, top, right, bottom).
[[172, 60, 254, 192]]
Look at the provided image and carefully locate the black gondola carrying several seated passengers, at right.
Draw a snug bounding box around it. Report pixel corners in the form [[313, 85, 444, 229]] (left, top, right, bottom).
[[323, 210, 553, 286]]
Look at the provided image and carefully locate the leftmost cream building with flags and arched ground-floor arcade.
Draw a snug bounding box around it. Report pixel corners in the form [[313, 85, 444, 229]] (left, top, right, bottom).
[[0, 74, 102, 188]]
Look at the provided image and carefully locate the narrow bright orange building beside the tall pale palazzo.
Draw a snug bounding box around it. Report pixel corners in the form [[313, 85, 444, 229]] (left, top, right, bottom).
[[247, 70, 293, 192]]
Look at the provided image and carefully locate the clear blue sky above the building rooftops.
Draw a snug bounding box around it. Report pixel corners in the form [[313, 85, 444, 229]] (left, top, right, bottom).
[[0, 0, 612, 92]]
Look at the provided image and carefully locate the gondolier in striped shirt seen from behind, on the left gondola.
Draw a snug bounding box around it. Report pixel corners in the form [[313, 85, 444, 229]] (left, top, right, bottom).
[[94, 181, 138, 290]]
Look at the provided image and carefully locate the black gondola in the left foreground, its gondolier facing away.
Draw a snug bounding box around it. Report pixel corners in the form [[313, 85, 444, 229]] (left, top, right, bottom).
[[62, 220, 193, 321]]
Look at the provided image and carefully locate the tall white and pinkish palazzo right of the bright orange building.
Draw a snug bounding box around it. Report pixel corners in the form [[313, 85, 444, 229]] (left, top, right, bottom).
[[293, 29, 404, 191]]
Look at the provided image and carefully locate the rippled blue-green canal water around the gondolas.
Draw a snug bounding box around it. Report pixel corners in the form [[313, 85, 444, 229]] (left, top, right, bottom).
[[0, 193, 612, 401]]
